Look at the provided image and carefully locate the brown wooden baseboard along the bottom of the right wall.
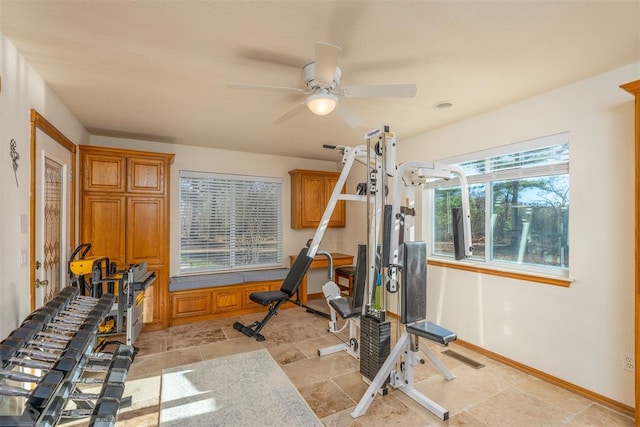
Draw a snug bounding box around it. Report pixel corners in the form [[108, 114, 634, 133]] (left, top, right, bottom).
[[455, 339, 635, 418]]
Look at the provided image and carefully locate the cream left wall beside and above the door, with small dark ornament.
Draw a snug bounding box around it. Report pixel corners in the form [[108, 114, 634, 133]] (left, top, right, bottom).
[[0, 32, 89, 339]]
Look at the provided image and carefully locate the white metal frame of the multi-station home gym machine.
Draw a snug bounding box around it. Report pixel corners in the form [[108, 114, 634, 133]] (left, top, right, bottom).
[[310, 127, 472, 420]]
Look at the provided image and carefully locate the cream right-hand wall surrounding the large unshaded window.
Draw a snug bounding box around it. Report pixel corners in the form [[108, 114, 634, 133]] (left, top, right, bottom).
[[398, 63, 640, 406]]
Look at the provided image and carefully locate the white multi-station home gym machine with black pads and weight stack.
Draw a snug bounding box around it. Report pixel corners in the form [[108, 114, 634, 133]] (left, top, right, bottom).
[[309, 127, 472, 420]]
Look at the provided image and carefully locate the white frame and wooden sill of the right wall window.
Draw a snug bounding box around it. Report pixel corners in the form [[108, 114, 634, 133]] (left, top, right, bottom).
[[422, 132, 572, 286]]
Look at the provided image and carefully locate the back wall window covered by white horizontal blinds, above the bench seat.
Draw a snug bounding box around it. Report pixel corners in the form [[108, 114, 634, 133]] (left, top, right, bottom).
[[180, 171, 282, 273]]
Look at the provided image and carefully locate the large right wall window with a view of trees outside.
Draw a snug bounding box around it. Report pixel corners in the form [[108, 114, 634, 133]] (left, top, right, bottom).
[[426, 134, 569, 276]]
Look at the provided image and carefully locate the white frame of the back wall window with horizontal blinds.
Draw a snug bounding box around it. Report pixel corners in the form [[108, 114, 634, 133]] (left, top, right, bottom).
[[178, 170, 284, 276]]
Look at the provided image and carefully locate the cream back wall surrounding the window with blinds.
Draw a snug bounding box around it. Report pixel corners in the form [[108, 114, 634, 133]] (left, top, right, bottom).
[[90, 136, 341, 282]]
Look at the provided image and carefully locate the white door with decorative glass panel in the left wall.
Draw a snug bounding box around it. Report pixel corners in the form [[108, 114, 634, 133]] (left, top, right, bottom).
[[32, 118, 73, 307]]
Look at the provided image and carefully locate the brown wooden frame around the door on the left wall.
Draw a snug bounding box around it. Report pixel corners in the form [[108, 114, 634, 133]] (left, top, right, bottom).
[[29, 108, 77, 311]]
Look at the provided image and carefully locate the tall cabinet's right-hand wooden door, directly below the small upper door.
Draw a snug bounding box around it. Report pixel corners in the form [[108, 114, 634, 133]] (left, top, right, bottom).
[[126, 196, 167, 265]]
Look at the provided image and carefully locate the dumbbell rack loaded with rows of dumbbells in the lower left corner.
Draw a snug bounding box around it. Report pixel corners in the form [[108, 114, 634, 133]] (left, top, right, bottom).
[[0, 286, 133, 427]]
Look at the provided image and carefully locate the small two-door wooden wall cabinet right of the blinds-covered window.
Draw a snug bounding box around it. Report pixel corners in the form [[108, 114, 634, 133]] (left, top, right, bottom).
[[289, 169, 346, 229]]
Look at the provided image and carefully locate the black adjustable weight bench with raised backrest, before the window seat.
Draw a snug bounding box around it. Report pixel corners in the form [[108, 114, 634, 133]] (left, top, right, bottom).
[[233, 247, 313, 341]]
